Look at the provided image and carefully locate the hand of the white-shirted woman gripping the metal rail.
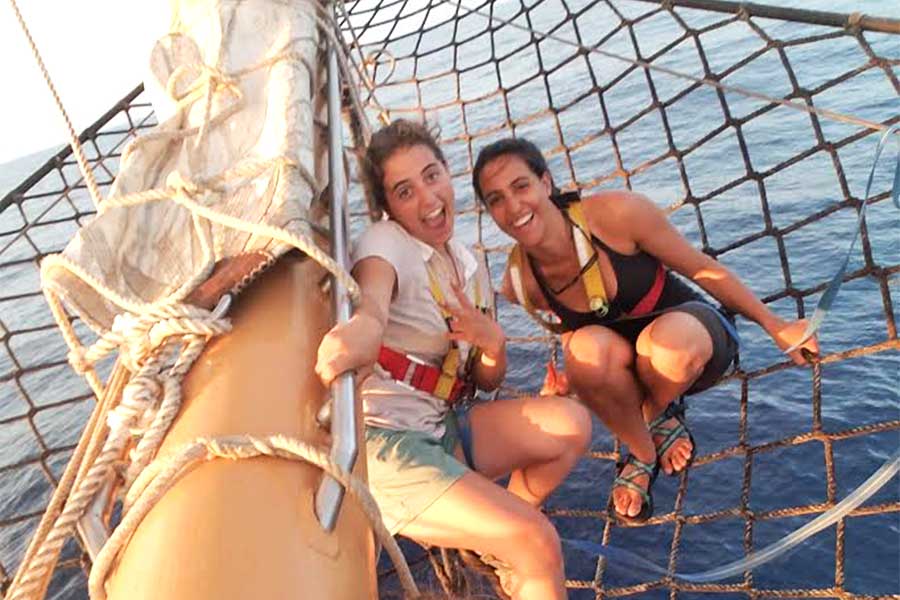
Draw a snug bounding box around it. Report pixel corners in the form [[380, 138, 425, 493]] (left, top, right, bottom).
[[316, 313, 382, 387]]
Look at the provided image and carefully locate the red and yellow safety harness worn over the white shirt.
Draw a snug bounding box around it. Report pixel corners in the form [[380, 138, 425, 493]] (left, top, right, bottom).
[[378, 254, 490, 404]]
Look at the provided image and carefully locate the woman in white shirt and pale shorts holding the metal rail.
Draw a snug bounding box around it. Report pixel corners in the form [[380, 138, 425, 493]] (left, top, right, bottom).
[[316, 120, 591, 600]]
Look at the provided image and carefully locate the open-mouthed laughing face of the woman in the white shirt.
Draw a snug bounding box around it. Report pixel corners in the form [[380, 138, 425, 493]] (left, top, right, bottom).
[[382, 144, 453, 249]]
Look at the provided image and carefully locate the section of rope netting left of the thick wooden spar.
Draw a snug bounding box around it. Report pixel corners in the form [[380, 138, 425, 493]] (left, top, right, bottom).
[[0, 86, 156, 598]]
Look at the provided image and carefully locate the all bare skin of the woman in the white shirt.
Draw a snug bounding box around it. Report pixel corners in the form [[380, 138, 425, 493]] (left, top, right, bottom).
[[316, 145, 591, 600]]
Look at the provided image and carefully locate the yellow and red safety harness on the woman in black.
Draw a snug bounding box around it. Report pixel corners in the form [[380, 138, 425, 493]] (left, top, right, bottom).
[[509, 201, 666, 333]]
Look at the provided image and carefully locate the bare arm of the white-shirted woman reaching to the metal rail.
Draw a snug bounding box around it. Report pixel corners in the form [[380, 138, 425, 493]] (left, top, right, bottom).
[[316, 256, 397, 386]]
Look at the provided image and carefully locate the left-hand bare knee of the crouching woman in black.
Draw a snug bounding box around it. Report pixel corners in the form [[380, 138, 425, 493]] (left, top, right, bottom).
[[564, 326, 634, 388]]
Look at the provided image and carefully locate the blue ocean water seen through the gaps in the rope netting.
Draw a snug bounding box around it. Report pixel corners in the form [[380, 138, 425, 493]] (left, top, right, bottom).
[[0, 0, 900, 599]]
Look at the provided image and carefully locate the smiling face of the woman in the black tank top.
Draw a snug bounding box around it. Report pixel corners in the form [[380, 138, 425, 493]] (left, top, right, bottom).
[[478, 154, 556, 248]]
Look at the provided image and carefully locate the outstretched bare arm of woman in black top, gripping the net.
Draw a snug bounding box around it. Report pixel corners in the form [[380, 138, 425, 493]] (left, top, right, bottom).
[[595, 192, 819, 363]]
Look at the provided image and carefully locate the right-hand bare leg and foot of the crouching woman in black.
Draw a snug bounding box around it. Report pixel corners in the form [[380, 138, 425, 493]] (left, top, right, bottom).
[[636, 312, 713, 474]]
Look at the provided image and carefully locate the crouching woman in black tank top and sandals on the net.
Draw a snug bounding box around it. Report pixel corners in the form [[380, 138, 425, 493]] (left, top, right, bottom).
[[472, 139, 818, 520]]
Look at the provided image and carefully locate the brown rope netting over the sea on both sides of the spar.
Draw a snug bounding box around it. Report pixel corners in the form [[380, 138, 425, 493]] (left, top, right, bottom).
[[0, 0, 900, 598]]
